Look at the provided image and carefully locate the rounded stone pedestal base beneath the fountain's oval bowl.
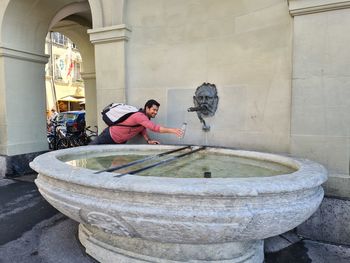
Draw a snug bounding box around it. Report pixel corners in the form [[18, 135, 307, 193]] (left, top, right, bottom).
[[79, 224, 264, 263]]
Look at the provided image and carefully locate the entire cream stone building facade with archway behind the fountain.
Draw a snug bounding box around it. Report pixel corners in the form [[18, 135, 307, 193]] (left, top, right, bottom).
[[0, 0, 350, 246]]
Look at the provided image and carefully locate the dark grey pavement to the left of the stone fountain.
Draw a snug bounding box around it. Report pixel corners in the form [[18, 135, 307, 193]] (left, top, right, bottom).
[[0, 176, 96, 263]]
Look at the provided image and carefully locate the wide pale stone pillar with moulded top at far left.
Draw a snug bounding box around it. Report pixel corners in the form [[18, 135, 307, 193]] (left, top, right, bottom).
[[0, 46, 48, 156]]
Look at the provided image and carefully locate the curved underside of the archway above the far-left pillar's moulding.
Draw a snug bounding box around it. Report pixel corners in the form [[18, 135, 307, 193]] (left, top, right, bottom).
[[0, 0, 93, 54]]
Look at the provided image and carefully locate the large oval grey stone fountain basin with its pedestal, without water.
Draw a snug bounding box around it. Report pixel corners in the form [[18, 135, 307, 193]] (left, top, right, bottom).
[[31, 145, 327, 263]]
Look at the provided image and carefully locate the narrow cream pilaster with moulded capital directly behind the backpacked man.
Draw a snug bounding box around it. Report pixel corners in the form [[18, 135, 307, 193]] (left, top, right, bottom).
[[88, 24, 131, 130]]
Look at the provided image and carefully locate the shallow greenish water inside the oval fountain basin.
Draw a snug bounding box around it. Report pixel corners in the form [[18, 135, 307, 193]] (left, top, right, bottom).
[[67, 152, 295, 178]]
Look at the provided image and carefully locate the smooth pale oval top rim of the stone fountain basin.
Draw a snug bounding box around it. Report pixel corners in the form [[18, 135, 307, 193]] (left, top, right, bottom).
[[30, 144, 327, 196]]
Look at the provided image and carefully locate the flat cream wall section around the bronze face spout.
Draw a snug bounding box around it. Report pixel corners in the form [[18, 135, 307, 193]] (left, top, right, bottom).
[[127, 0, 292, 152]]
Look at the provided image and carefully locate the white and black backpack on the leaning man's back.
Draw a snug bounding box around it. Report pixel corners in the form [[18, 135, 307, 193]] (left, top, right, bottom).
[[101, 103, 140, 127]]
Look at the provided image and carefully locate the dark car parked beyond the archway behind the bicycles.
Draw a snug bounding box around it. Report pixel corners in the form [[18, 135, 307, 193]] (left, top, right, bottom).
[[57, 111, 85, 133]]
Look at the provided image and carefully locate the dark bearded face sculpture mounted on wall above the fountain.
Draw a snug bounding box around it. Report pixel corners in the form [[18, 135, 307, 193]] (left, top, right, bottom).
[[193, 83, 219, 117]]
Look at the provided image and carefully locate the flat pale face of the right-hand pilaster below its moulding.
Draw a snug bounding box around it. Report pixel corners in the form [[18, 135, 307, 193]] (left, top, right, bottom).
[[291, 9, 350, 174]]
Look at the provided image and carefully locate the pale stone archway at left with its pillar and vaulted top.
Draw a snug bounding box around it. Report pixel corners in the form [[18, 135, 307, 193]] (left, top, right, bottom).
[[0, 0, 96, 156]]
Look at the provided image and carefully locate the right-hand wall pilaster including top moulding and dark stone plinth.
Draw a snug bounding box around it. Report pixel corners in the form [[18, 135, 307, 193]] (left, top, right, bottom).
[[289, 0, 350, 245]]
